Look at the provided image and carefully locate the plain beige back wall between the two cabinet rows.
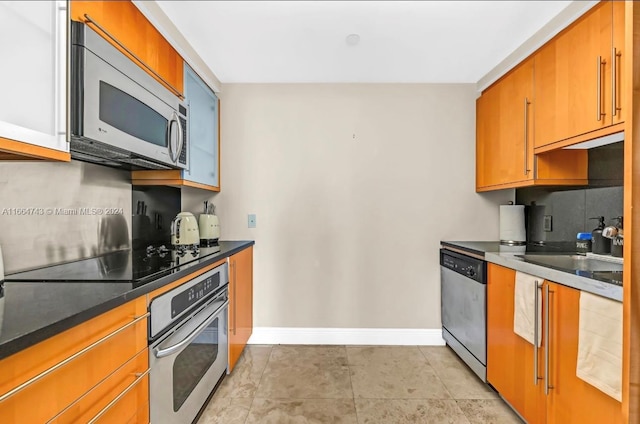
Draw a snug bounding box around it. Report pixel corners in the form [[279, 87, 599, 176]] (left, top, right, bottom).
[[216, 84, 513, 328]]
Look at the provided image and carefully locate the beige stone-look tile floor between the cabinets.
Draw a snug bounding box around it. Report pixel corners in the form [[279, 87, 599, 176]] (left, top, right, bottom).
[[198, 345, 521, 424]]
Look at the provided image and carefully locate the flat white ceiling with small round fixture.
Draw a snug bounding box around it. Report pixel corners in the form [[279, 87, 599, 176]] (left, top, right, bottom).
[[158, 1, 572, 83]]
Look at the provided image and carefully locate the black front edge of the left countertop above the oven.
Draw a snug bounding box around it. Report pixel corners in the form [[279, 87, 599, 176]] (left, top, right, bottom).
[[0, 240, 255, 360]]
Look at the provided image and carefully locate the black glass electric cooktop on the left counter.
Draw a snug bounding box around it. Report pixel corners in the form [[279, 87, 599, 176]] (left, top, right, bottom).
[[5, 246, 220, 288]]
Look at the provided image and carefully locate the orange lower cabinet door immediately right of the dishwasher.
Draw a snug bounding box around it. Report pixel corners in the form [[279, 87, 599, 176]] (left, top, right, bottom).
[[487, 264, 546, 424]]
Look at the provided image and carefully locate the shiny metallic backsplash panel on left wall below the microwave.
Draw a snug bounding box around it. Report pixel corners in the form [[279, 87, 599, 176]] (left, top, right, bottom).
[[0, 161, 131, 273]]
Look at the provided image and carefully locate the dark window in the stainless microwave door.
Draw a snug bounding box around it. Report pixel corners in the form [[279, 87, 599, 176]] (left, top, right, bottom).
[[100, 81, 168, 147]]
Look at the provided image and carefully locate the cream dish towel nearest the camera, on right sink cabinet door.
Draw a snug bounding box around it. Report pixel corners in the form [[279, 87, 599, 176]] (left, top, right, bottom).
[[576, 292, 622, 402]]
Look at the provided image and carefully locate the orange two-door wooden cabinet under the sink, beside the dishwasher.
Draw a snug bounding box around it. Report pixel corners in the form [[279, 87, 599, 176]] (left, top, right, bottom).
[[487, 264, 624, 424]]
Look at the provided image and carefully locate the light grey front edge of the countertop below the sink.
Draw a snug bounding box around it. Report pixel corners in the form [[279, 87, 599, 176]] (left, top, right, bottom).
[[484, 252, 622, 302]]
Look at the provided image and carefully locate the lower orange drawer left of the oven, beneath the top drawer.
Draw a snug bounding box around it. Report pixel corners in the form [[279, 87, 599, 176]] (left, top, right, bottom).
[[51, 349, 149, 424]]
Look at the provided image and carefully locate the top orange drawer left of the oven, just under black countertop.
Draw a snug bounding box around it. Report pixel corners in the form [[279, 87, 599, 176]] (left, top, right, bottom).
[[0, 298, 147, 423]]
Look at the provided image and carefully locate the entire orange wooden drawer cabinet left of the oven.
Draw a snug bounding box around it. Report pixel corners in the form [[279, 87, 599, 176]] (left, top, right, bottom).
[[0, 297, 149, 423]]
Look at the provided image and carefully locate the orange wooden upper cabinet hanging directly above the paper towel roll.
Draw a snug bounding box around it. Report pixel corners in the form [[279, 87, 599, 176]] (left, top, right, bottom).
[[476, 58, 588, 191]]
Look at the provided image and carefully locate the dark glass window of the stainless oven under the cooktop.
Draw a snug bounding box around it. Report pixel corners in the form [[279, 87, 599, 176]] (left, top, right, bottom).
[[173, 318, 220, 412]]
